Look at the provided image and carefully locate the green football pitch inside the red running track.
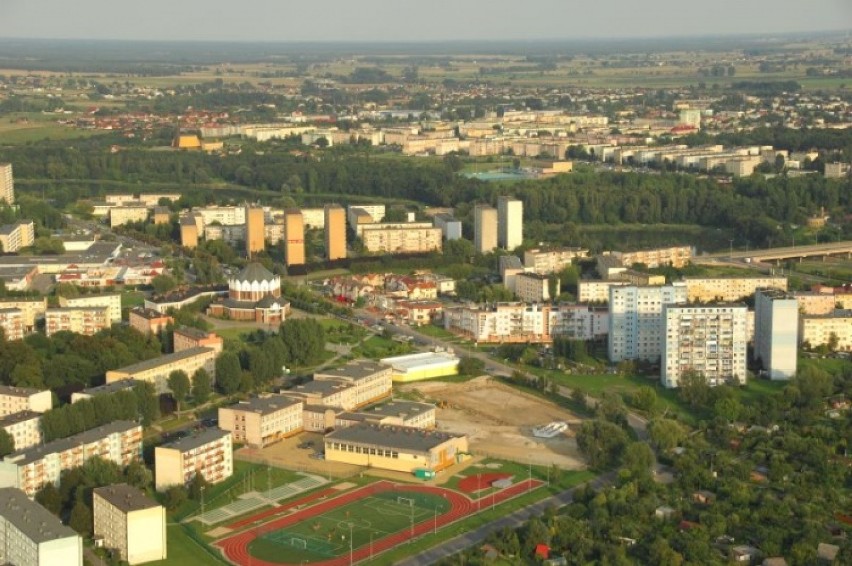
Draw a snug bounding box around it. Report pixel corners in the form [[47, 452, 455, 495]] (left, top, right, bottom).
[[248, 490, 451, 564]]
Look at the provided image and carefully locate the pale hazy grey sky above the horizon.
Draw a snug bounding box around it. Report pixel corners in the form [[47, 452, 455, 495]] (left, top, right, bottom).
[[5, 0, 852, 42]]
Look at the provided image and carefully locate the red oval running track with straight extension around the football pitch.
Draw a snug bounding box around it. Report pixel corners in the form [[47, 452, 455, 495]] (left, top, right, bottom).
[[215, 480, 542, 566]]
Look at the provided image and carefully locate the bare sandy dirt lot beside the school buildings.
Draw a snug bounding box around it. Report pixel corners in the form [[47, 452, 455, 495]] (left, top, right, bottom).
[[401, 376, 586, 470]]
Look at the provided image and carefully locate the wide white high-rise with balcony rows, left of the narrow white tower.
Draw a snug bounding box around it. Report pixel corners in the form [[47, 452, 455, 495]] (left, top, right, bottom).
[[660, 304, 748, 388]]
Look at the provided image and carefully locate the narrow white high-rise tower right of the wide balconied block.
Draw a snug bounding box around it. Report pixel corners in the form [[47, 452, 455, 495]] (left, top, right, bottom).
[[754, 289, 799, 379]]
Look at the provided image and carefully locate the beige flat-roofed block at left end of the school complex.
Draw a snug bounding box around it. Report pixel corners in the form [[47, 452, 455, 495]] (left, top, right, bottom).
[[219, 395, 303, 448]]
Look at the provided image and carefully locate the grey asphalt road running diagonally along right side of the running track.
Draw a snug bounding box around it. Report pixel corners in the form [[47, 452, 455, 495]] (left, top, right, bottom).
[[396, 473, 615, 566]]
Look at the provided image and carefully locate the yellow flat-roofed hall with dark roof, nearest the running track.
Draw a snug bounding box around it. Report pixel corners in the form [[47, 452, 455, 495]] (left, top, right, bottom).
[[323, 424, 468, 473]]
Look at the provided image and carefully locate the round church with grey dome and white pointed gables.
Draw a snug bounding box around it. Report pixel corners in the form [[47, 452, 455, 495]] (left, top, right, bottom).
[[207, 263, 290, 324]]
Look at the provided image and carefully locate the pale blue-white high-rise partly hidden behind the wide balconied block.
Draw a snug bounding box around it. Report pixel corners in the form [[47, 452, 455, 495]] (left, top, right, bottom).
[[608, 283, 686, 362]]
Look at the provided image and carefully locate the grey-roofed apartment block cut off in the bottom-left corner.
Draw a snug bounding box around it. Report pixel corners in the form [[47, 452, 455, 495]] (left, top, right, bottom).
[[0, 488, 83, 566]]
